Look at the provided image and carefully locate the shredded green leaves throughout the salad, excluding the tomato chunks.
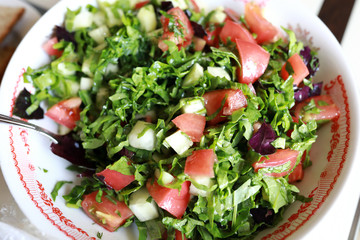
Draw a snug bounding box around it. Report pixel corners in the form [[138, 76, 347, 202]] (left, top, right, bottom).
[[16, 1, 324, 239]]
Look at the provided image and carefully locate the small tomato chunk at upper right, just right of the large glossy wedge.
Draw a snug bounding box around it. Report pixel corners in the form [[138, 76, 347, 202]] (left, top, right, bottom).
[[280, 53, 309, 85]]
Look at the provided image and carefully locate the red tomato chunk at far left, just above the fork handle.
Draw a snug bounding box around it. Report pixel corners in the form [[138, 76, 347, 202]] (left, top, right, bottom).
[[45, 97, 81, 129]]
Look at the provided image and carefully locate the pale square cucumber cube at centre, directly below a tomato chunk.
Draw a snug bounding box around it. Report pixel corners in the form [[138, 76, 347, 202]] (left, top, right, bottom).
[[163, 130, 193, 155]]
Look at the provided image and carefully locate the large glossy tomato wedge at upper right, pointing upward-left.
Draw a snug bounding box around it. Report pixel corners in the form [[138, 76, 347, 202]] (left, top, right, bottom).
[[236, 39, 270, 84]]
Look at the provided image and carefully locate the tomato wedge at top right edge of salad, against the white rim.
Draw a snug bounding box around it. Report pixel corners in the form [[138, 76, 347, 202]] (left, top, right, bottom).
[[245, 2, 279, 44]]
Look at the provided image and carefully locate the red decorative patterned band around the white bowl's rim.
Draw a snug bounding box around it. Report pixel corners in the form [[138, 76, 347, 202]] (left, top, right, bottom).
[[0, 0, 351, 239]]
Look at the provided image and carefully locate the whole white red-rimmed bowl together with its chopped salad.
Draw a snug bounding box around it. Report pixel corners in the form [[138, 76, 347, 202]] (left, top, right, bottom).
[[0, 0, 359, 239]]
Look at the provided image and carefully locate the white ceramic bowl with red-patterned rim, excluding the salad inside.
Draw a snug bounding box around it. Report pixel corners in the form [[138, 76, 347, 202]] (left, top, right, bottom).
[[0, 0, 360, 239]]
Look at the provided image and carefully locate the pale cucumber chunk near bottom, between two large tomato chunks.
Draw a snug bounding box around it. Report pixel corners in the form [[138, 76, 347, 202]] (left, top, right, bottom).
[[129, 187, 159, 222]]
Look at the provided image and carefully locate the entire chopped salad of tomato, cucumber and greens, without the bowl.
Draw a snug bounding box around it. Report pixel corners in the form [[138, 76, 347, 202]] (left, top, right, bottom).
[[15, 0, 339, 239]]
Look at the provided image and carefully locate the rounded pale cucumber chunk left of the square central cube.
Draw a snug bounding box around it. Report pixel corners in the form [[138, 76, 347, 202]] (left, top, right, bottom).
[[128, 121, 156, 151]]
